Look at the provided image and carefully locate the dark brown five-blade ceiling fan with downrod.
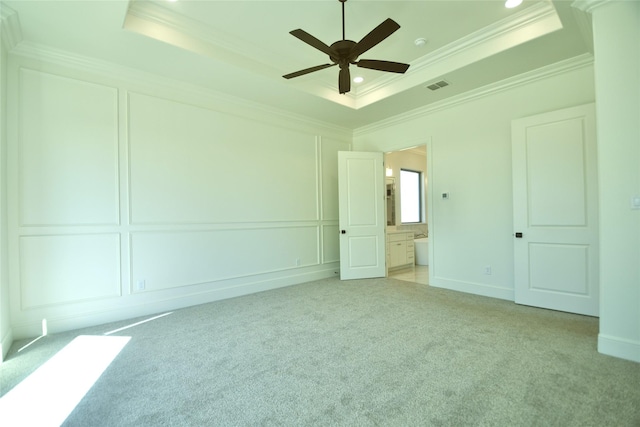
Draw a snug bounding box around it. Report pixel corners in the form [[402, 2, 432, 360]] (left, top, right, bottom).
[[282, 0, 409, 93]]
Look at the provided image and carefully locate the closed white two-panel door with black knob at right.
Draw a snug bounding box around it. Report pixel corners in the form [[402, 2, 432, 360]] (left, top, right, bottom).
[[512, 104, 599, 316]]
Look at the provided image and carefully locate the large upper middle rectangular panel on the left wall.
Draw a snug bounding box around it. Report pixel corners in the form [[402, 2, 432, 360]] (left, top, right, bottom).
[[129, 93, 318, 224]]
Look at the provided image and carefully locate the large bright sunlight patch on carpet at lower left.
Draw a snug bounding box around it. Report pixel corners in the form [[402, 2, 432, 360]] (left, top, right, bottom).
[[0, 335, 131, 426]]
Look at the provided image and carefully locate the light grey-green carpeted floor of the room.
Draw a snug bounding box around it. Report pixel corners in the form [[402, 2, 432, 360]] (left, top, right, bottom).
[[0, 279, 640, 427]]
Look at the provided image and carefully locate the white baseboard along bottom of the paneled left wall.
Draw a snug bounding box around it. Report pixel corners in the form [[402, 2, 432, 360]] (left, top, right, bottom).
[[12, 265, 336, 339]]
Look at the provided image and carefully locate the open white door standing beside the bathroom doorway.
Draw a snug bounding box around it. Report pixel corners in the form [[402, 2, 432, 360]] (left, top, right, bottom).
[[338, 151, 386, 280]]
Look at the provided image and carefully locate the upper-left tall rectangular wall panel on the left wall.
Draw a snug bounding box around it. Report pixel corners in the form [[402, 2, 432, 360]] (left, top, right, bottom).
[[18, 68, 119, 226]]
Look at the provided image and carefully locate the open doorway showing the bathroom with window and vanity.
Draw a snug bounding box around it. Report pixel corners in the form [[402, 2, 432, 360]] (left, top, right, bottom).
[[384, 145, 429, 285]]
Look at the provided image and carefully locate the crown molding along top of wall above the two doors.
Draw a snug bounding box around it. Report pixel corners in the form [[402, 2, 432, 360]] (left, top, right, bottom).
[[353, 53, 593, 138]]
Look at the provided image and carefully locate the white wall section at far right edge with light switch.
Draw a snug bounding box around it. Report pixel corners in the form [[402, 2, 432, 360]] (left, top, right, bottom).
[[593, 1, 640, 362]]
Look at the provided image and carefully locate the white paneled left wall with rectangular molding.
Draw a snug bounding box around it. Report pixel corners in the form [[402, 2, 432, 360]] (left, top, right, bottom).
[[3, 50, 350, 338]]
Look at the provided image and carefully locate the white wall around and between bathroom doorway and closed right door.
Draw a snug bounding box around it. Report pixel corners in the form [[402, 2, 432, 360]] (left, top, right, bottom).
[[354, 59, 594, 300]]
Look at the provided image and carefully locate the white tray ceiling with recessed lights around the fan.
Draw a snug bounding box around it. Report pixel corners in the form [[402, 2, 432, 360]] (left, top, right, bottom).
[[1, 0, 590, 129]]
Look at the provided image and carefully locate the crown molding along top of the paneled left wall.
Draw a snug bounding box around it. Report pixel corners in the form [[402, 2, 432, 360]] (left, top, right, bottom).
[[11, 42, 352, 139]]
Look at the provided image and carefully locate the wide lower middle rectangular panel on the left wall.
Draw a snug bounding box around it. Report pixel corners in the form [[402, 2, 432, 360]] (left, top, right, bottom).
[[131, 226, 320, 291]]
